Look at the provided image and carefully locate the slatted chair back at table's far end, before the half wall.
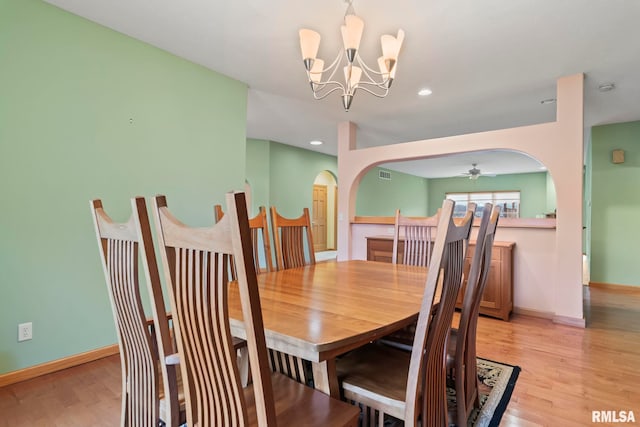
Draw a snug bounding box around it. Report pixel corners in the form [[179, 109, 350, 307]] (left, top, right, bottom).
[[391, 209, 439, 267]]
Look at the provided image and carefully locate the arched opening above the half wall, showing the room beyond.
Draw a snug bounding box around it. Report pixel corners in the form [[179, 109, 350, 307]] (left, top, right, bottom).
[[356, 150, 557, 218]]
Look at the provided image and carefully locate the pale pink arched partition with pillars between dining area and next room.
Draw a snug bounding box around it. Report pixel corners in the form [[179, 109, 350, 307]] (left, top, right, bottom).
[[338, 74, 584, 327]]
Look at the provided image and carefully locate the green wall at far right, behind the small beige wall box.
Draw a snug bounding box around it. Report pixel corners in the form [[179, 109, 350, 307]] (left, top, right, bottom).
[[590, 121, 640, 286]]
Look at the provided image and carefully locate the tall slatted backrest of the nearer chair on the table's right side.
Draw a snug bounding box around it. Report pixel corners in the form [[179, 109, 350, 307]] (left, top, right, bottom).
[[404, 200, 475, 427]]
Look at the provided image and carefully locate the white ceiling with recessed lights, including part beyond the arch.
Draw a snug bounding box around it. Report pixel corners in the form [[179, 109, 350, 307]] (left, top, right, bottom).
[[45, 0, 640, 177]]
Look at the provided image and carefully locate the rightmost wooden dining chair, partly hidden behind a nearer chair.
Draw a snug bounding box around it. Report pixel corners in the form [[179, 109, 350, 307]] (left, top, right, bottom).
[[447, 203, 500, 426]]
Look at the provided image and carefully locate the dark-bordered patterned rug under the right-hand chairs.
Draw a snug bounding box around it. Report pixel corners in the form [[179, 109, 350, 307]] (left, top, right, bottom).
[[384, 358, 520, 427]]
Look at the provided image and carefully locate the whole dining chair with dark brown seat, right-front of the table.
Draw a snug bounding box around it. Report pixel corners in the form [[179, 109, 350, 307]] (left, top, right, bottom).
[[337, 200, 473, 427]]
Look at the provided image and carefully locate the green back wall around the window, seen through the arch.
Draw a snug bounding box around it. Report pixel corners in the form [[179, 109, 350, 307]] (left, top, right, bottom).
[[429, 172, 555, 218]]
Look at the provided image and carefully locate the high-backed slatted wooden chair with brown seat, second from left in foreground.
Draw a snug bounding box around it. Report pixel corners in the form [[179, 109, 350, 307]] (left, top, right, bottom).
[[153, 193, 359, 427]]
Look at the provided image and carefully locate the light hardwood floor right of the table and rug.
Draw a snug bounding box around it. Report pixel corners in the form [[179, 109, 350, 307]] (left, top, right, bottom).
[[478, 288, 640, 426]]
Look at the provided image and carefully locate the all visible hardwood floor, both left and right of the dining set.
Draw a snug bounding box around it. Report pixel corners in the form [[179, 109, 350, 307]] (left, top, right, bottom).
[[0, 287, 640, 427]]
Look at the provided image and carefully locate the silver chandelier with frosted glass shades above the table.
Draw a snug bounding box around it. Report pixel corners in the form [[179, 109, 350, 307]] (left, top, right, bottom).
[[300, 0, 404, 111]]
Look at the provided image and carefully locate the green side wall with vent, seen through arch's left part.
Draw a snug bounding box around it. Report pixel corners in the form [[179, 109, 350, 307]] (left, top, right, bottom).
[[356, 167, 430, 216]]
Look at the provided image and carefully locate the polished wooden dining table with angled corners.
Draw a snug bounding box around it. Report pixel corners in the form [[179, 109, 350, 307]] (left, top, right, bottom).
[[229, 260, 427, 396]]
